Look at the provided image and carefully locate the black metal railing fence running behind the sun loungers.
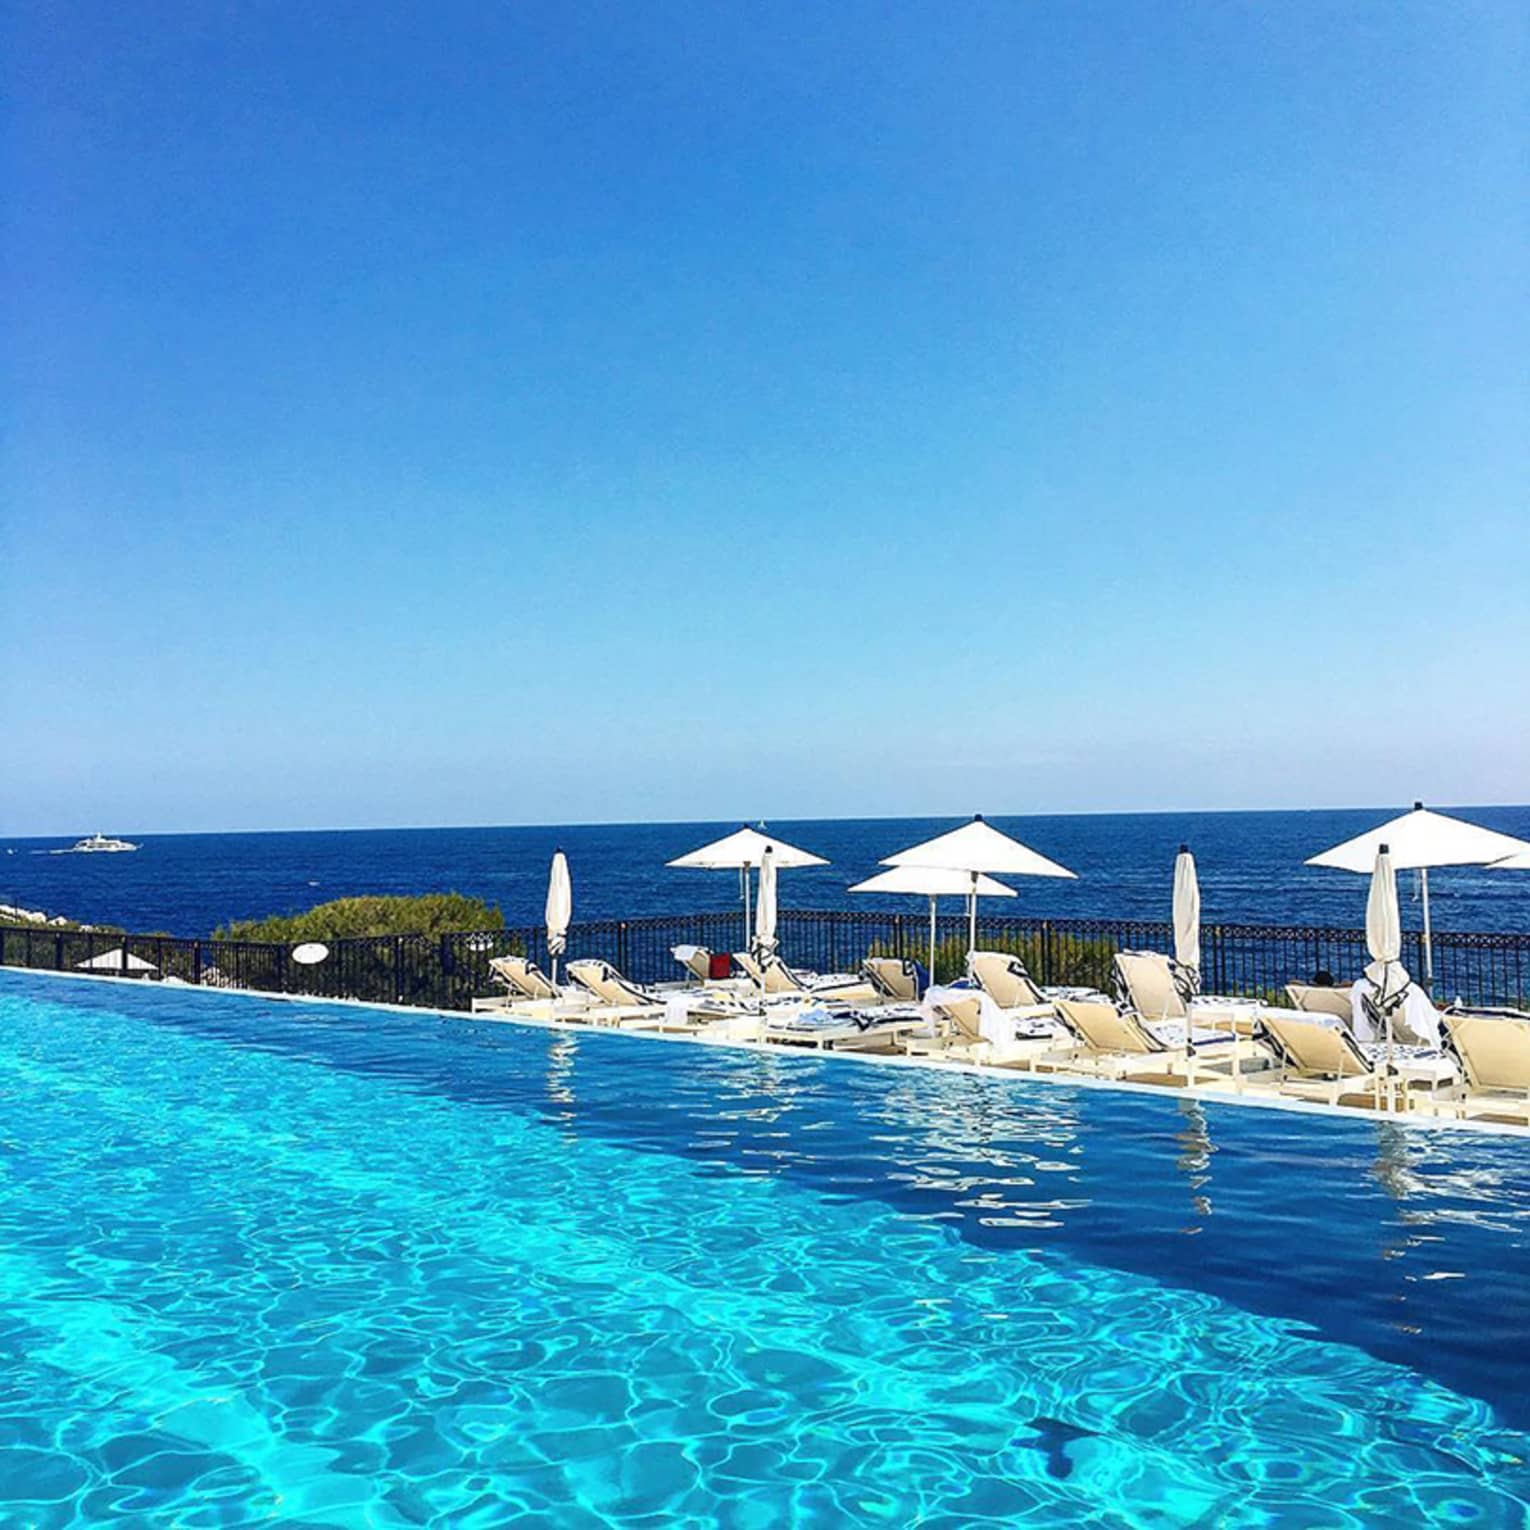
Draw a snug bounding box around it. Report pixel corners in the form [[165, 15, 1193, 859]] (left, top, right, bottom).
[[0, 910, 1530, 1010]]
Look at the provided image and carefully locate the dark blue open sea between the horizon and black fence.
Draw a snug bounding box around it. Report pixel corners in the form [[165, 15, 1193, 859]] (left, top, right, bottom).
[[0, 806, 1530, 935]]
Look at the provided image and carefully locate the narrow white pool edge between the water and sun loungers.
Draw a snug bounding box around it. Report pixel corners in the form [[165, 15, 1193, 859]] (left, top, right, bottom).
[[11, 967, 1530, 1137]]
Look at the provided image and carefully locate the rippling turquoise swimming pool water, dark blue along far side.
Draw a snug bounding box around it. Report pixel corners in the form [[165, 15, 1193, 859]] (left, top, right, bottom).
[[0, 975, 1530, 1527]]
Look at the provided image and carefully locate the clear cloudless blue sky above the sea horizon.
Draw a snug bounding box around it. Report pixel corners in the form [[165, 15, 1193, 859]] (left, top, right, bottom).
[[0, 0, 1530, 834]]
